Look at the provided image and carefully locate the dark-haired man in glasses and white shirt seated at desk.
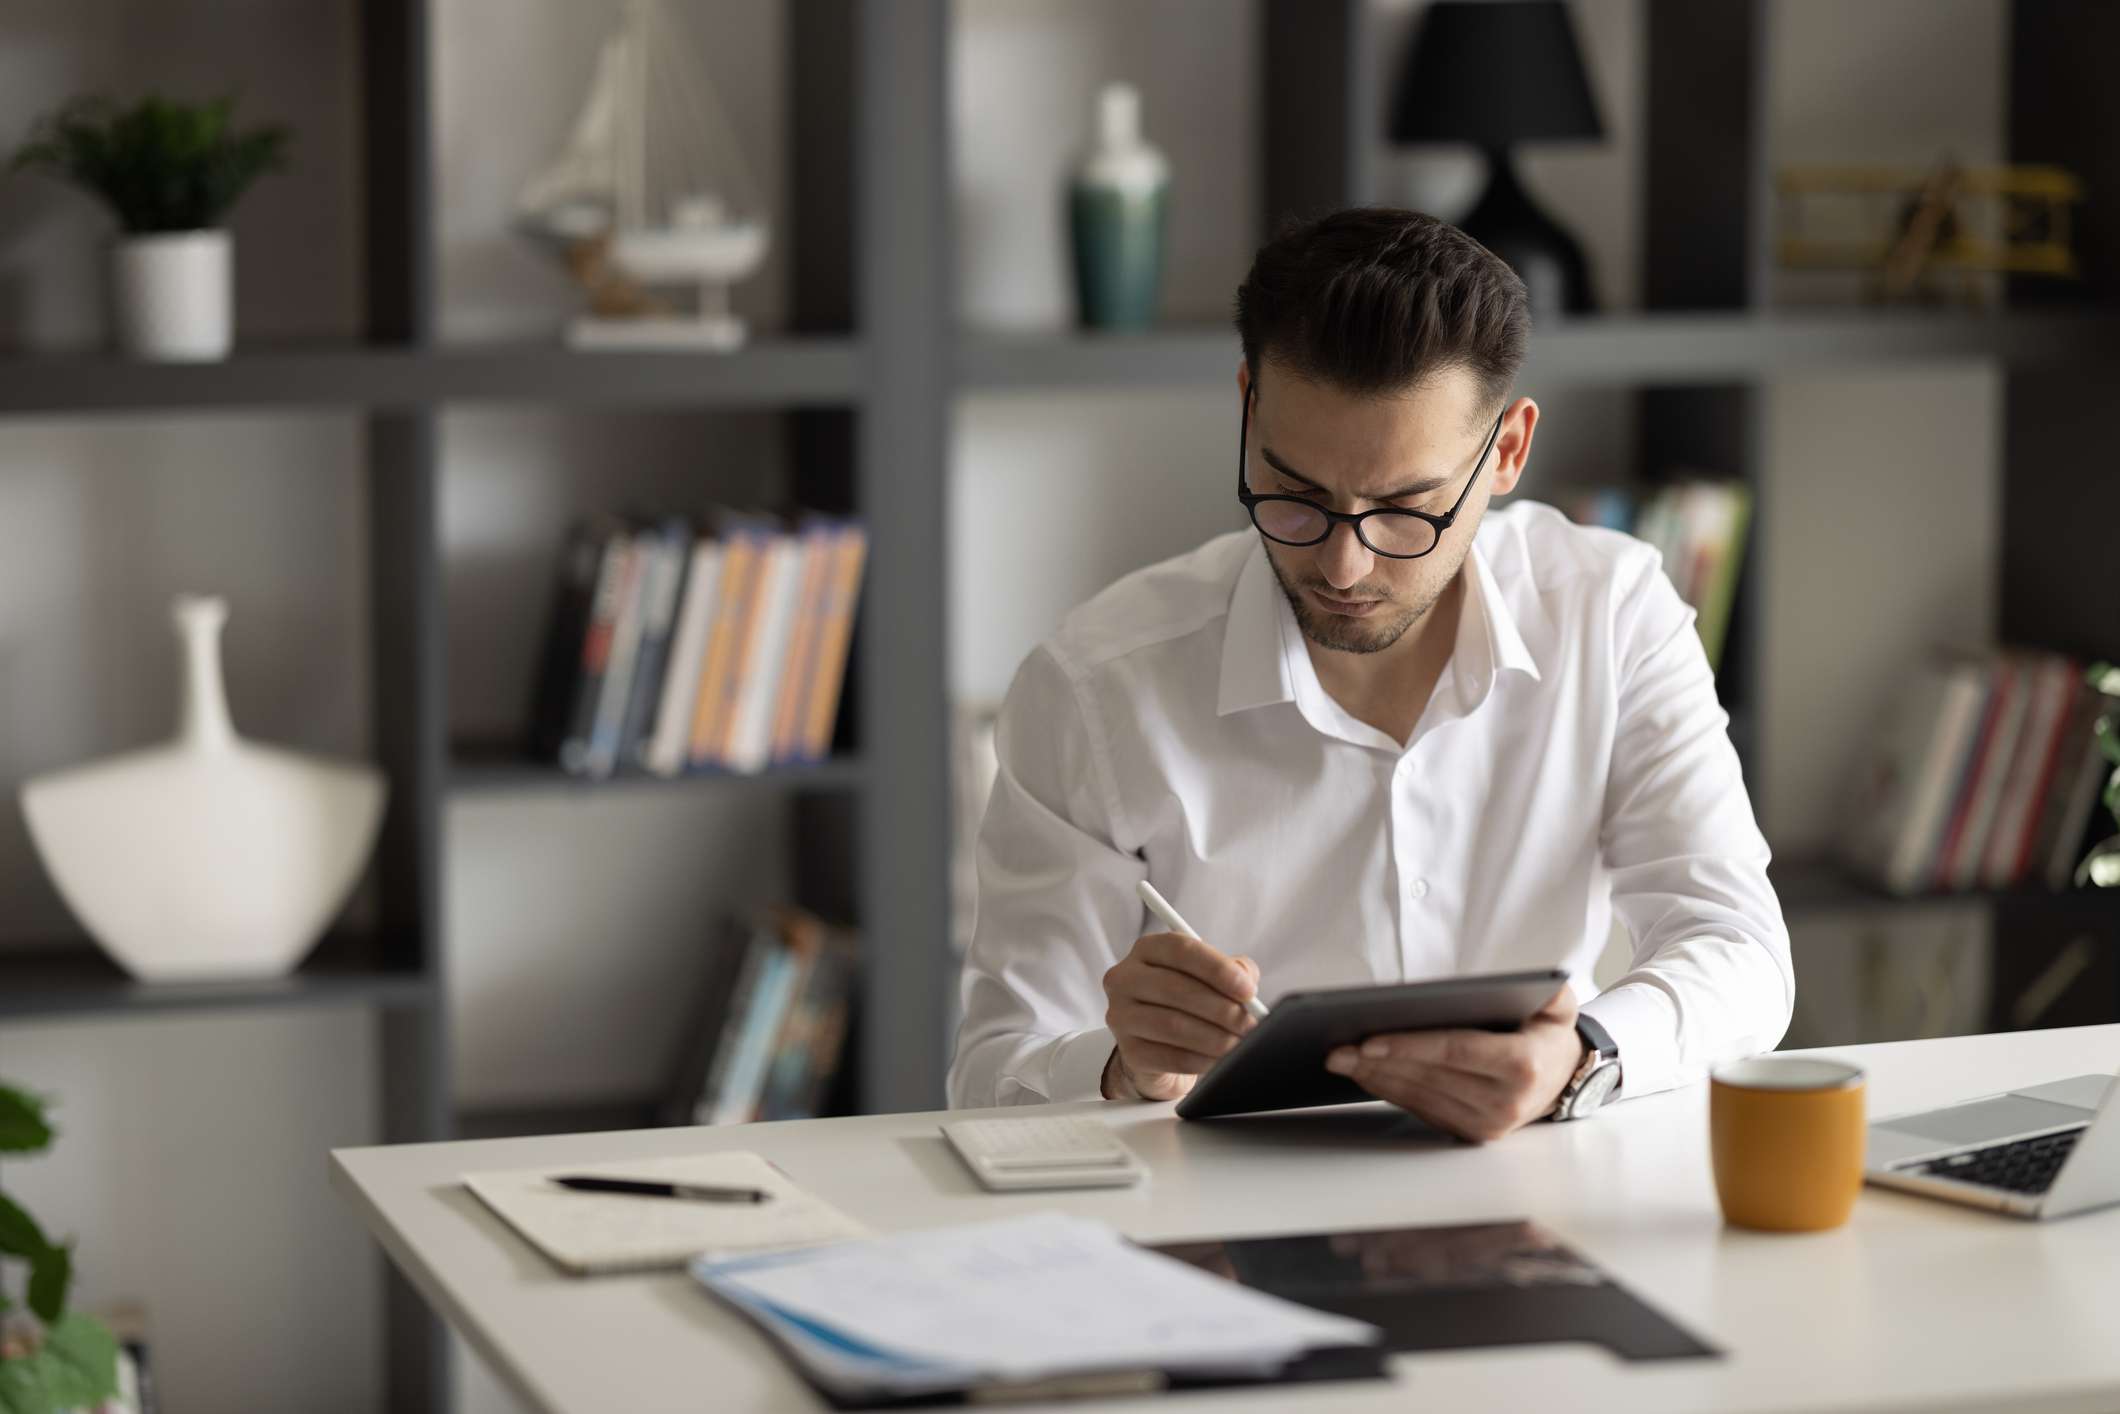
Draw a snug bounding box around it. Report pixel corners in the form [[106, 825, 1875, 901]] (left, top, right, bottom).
[[950, 208, 1796, 1141]]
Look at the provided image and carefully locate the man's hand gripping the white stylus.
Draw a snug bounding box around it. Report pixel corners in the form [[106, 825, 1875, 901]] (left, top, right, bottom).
[[1105, 933, 1259, 1100]]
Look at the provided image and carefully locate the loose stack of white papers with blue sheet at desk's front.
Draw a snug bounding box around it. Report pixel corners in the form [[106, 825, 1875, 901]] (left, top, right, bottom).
[[691, 1213, 1382, 1399]]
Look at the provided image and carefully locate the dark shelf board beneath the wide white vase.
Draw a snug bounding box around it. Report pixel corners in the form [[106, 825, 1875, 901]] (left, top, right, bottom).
[[0, 935, 437, 1020]]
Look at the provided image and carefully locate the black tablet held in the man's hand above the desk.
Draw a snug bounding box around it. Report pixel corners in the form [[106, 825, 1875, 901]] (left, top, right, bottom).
[[1179, 969, 1569, 1119]]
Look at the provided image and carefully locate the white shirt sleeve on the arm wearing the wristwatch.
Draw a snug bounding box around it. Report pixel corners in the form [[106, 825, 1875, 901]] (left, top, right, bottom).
[[1584, 562, 1796, 1096]]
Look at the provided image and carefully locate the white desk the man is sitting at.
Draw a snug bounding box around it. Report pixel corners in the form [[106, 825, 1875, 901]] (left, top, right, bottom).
[[333, 1026, 2120, 1414]]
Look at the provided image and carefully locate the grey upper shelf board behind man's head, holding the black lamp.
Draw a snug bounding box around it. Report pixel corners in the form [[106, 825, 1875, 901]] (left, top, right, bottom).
[[956, 310, 2120, 392]]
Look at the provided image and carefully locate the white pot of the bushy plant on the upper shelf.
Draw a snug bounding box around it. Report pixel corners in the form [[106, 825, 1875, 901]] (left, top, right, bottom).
[[110, 231, 235, 363]]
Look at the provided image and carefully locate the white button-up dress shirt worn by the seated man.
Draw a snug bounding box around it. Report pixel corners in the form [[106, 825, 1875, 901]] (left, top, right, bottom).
[[950, 502, 1796, 1107]]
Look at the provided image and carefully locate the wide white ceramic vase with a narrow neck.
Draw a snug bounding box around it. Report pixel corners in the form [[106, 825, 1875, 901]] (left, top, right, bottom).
[[21, 598, 384, 982]]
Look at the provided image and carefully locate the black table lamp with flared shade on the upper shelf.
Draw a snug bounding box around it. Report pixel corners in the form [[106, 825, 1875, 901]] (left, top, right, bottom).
[[1391, 0, 1605, 318]]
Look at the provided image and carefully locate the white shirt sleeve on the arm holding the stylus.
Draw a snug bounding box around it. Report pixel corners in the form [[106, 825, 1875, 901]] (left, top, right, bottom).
[[950, 649, 1147, 1109]]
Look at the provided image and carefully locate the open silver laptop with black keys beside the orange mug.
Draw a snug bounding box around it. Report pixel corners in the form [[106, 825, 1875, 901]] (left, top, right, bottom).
[[1866, 1075, 2120, 1217]]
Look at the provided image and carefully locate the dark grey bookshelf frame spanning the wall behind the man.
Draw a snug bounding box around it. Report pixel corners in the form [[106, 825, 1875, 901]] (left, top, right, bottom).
[[0, 0, 2120, 1410]]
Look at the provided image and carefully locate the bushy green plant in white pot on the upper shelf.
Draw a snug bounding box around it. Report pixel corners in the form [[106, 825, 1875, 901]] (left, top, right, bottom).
[[13, 95, 288, 363]]
